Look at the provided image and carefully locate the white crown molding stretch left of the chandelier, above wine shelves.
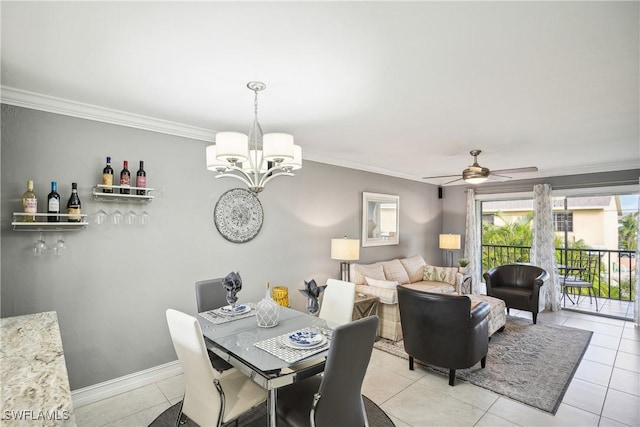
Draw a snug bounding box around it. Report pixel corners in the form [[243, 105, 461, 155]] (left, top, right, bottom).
[[0, 86, 215, 142]]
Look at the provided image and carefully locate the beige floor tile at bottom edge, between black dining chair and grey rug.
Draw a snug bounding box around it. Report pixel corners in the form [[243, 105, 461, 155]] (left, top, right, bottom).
[[381, 379, 485, 426]]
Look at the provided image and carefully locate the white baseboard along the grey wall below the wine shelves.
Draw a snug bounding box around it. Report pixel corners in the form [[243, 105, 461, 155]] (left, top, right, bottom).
[[71, 360, 182, 408]]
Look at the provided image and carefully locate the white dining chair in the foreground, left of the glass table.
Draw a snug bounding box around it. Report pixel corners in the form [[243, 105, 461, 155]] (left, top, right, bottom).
[[166, 309, 267, 426]]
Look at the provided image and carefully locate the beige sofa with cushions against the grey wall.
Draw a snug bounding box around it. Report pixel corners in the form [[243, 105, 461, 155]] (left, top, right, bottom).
[[349, 255, 463, 341]]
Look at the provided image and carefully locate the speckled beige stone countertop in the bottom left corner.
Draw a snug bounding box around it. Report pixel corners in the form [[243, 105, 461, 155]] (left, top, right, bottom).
[[0, 311, 76, 427]]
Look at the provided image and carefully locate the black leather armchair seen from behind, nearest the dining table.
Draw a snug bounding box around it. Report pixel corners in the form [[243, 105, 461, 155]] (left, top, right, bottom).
[[397, 285, 491, 386]]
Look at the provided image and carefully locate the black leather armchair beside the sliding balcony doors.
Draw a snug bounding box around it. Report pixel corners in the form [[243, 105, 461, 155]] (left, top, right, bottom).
[[484, 264, 549, 324]]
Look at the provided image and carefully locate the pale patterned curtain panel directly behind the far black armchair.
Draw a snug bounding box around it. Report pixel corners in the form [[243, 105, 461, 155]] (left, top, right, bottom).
[[531, 184, 561, 311]]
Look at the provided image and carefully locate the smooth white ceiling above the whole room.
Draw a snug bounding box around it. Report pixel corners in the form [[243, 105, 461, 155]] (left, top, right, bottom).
[[1, 1, 640, 183]]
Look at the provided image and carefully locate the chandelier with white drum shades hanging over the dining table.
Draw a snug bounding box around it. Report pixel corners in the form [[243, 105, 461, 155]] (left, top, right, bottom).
[[207, 82, 302, 194]]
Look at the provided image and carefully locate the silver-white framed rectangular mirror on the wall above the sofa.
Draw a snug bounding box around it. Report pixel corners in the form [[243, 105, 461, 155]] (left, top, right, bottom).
[[362, 192, 400, 248]]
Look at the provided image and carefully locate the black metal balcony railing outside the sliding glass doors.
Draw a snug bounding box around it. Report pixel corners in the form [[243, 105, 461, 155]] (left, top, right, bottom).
[[482, 245, 637, 301]]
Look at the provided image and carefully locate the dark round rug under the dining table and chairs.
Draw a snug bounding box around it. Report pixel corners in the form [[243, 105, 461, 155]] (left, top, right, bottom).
[[149, 396, 395, 427]]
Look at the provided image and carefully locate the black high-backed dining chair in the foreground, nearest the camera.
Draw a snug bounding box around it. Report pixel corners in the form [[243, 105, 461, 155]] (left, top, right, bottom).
[[277, 316, 378, 427]]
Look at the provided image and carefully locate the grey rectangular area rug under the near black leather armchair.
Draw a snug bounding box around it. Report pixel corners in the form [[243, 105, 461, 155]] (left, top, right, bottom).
[[374, 316, 593, 414]]
